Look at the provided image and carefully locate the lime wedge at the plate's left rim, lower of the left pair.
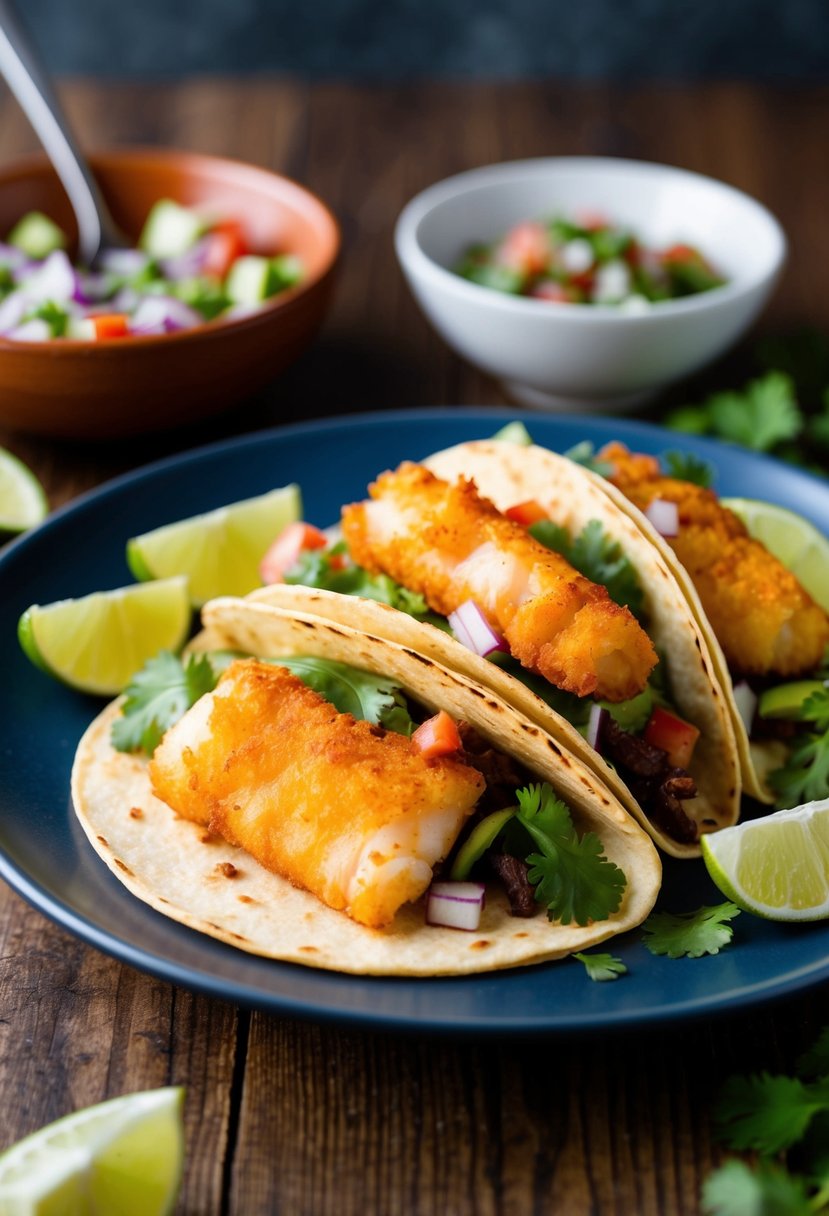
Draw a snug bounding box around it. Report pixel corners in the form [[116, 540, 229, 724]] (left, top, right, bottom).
[[17, 578, 191, 696]]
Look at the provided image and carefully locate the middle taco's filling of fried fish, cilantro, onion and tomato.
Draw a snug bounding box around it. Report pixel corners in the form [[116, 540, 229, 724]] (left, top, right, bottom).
[[255, 459, 724, 846]]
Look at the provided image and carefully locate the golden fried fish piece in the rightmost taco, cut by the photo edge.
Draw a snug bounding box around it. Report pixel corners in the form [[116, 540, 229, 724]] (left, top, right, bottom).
[[599, 443, 829, 676]]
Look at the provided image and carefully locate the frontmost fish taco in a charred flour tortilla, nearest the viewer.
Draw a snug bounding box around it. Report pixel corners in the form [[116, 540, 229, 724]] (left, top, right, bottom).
[[72, 598, 661, 975]]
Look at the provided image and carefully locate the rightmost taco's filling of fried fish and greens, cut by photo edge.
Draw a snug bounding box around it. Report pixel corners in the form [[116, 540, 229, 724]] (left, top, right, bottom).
[[598, 443, 829, 806]]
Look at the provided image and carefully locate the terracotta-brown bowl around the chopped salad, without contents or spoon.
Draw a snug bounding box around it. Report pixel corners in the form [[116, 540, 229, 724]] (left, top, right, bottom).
[[0, 148, 340, 439]]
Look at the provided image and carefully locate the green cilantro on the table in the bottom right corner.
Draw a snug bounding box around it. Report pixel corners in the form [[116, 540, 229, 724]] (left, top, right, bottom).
[[703, 1028, 829, 1216]]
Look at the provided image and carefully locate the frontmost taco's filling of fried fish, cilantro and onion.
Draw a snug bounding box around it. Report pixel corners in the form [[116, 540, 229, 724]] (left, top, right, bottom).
[[113, 654, 626, 929]]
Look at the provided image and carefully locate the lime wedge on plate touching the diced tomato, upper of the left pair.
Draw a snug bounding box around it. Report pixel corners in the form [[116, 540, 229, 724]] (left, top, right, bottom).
[[126, 485, 303, 608]]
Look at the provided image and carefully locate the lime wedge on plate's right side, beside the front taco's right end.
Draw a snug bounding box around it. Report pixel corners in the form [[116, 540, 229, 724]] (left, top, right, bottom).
[[701, 799, 829, 921]]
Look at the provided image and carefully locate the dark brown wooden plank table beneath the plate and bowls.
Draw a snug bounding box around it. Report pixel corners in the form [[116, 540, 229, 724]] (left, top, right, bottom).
[[0, 80, 829, 1216]]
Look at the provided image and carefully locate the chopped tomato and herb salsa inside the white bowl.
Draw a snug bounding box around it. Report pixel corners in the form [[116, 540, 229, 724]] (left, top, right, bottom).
[[453, 215, 726, 311]]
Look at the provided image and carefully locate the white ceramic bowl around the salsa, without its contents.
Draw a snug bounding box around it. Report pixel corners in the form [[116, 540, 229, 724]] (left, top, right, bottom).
[[395, 157, 786, 410]]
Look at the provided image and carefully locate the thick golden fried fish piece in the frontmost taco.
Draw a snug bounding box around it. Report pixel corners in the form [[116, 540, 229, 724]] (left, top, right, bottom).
[[150, 660, 485, 928]]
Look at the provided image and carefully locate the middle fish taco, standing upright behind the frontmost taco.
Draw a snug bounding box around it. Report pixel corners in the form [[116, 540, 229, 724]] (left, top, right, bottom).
[[252, 440, 740, 857]]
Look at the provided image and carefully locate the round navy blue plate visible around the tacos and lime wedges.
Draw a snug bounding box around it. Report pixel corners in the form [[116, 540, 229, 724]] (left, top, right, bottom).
[[0, 409, 829, 1034]]
